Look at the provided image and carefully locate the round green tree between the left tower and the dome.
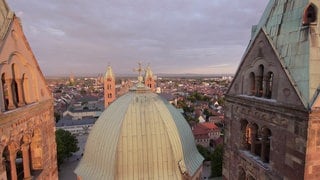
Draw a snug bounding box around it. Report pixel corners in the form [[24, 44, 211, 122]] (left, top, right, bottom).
[[56, 129, 79, 166]]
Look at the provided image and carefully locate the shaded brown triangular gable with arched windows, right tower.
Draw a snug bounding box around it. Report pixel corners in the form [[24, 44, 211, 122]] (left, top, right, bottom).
[[227, 30, 304, 106]]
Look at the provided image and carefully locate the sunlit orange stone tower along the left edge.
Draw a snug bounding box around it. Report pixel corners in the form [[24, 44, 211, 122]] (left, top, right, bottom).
[[0, 0, 58, 179]]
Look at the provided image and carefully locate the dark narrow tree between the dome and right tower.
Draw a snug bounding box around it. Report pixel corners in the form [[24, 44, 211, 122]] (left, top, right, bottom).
[[211, 145, 223, 177]]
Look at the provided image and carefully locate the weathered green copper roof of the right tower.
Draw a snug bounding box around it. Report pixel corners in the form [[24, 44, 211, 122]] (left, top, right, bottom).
[[247, 0, 320, 108]]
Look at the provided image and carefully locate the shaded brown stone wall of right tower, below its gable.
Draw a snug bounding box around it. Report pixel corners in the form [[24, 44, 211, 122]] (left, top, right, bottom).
[[223, 96, 308, 180]]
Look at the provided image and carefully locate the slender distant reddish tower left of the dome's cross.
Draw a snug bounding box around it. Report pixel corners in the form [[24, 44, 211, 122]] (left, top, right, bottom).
[[104, 66, 116, 108]]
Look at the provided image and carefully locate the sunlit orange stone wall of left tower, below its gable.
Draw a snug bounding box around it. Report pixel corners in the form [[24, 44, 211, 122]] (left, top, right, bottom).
[[0, 100, 58, 179]]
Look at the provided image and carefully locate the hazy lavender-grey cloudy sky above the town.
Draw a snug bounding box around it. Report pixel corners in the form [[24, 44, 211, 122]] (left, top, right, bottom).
[[6, 0, 268, 76]]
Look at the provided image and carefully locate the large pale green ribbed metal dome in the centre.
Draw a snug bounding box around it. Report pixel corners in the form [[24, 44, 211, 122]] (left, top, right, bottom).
[[75, 86, 203, 179]]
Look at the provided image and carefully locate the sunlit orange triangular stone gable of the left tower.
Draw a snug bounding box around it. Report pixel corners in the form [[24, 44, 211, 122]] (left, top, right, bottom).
[[0, 16, 51, 110]]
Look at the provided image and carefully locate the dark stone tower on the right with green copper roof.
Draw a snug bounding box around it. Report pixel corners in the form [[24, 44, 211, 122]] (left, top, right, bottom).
[[223, 0, 320, 180]]
